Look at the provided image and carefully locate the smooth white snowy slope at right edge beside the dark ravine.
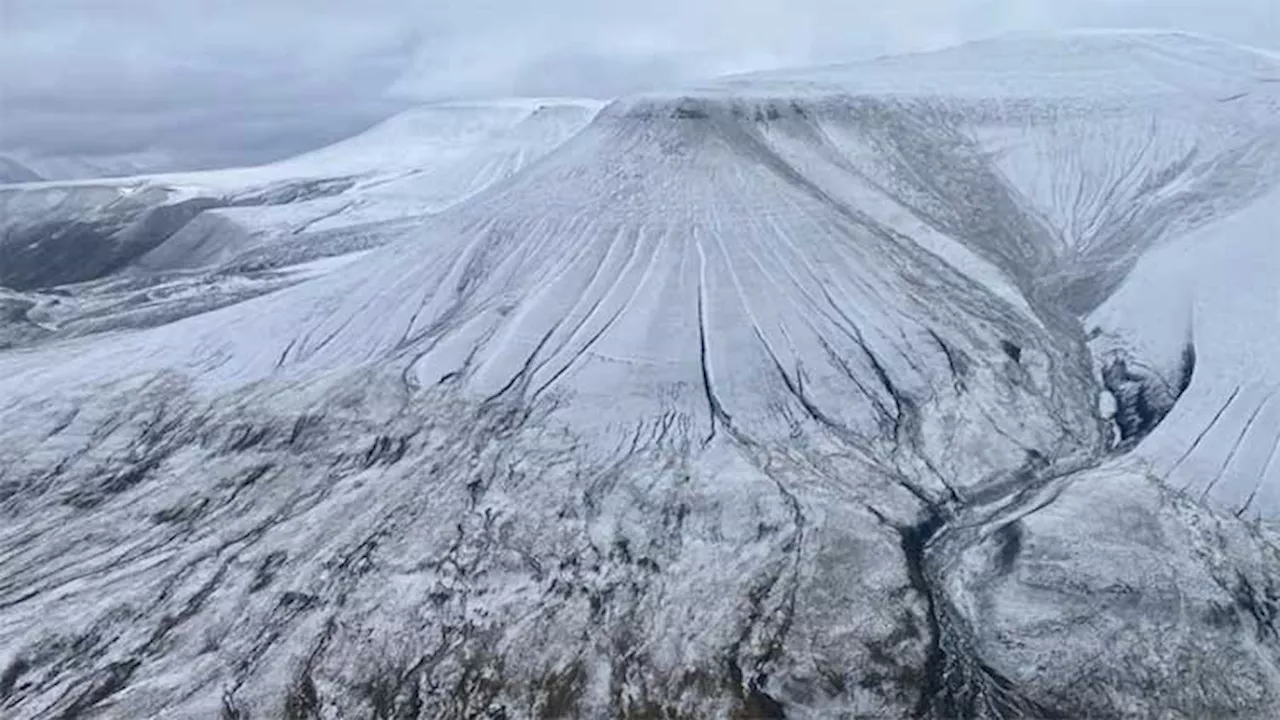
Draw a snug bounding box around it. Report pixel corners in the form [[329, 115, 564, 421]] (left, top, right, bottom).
[[1089, 181, 1280, 516]]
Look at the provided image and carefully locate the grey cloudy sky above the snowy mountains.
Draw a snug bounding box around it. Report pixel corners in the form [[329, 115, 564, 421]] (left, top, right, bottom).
[[0, 0, 1280, 174]]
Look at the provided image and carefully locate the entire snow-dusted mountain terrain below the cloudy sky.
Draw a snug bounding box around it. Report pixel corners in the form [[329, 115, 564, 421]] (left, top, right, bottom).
[[0, 33, 1280, 719]]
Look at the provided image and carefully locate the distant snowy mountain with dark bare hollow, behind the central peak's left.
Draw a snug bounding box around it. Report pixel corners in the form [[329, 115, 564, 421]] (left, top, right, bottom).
[[0, 100, 598, 290]]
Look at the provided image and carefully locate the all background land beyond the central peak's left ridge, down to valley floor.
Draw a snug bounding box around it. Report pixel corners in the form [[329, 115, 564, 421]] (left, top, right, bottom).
[[0, 100, 595, 346]]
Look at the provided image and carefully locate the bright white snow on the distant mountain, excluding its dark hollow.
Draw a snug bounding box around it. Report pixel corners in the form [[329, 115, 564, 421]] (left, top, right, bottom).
[[0, 99, 599, 278]]
